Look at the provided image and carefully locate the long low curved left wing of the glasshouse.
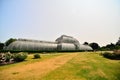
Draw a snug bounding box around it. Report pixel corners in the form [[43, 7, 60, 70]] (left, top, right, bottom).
[[6, 41, 57, 51]]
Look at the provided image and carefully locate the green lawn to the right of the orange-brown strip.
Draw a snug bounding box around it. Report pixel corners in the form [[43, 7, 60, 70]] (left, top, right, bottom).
[[42, 52, 120, 80]]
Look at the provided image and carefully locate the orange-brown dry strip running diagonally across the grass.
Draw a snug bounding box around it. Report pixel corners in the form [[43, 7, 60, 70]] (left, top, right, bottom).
[[0, 53, 77, 80]]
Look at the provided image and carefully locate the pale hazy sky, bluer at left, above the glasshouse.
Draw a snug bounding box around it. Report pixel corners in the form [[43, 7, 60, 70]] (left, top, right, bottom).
[[0, 0, 120, 46]]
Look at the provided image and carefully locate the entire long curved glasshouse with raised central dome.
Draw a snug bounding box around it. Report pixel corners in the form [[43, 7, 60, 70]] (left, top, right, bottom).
[[4, 35, 92, 51]]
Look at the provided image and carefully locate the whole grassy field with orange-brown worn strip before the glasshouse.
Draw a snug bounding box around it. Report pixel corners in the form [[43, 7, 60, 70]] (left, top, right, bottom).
[[0, 52, 120, 80]]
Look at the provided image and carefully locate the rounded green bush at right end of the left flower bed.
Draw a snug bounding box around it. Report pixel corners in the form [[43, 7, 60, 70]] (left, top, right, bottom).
[[14, 52, 27, 62]]
